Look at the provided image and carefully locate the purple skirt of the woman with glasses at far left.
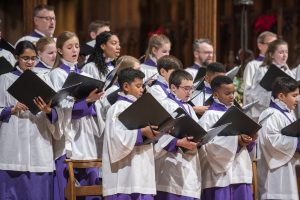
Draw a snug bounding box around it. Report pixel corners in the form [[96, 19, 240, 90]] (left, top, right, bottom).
[[0, 170, 53, 200]]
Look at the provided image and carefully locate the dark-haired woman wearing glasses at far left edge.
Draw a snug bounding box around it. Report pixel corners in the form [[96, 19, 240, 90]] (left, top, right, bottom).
[[0, 40, 54, 200]]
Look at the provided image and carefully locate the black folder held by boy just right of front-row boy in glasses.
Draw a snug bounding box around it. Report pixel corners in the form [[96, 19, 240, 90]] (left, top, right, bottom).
[[213, 106, 261, 136]]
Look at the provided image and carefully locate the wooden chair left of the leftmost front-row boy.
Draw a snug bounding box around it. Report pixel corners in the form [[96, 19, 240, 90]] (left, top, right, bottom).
[[65, 159, 102, 200]]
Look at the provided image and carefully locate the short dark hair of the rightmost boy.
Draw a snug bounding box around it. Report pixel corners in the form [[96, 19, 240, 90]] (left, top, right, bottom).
[[272, 77, 299, 98]]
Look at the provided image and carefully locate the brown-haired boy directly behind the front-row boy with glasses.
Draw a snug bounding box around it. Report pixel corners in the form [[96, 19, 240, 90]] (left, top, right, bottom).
[[148, 55, 182, 103]]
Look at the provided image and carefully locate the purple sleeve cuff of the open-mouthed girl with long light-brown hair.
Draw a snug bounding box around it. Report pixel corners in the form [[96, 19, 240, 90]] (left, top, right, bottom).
[[72, 99, 96, 119]]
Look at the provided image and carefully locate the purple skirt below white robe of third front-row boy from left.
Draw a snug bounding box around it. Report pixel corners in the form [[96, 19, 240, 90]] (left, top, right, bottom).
[[201, 183, 253, 200]]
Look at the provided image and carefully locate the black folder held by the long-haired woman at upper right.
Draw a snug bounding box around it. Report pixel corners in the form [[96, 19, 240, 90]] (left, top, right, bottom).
[[259, 64, 293, 91]]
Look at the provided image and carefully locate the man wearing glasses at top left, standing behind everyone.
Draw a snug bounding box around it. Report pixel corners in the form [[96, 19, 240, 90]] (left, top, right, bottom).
[[15, 4, 56, 46]]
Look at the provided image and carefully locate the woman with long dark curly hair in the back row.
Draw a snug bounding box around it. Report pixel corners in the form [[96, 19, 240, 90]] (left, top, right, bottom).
[[82, 31, 121, 81]]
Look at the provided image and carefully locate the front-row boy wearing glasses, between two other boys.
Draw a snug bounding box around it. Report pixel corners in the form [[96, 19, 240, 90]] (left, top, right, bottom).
[[155, 70, 201, 200]]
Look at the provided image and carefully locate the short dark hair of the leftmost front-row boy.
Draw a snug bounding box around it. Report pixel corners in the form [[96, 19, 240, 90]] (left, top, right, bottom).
[[118, 68, 145, 89]]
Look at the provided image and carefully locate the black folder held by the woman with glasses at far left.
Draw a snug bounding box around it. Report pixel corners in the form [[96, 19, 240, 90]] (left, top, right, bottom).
[[7, 70, 77, 115]]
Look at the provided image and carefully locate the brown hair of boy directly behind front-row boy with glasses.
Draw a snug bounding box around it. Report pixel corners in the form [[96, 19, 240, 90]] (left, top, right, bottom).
[[157, 55, 183, 74]]
